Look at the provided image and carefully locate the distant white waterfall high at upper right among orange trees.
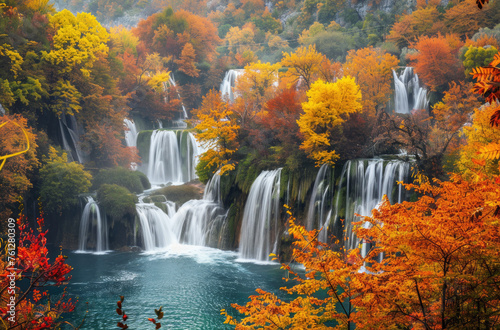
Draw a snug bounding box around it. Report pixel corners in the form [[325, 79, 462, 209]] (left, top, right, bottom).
[[392, 67, 429, 113]]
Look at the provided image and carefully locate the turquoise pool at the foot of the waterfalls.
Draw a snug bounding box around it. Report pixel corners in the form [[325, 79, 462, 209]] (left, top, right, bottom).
[[62, 245, 284, 330]]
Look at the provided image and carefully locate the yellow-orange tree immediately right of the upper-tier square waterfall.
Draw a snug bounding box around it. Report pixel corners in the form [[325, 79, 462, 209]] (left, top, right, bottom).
[[193, 90, 239, 181]]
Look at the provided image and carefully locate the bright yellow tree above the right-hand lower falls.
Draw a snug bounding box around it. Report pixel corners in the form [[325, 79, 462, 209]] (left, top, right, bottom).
[[297, 76, 362, 166]]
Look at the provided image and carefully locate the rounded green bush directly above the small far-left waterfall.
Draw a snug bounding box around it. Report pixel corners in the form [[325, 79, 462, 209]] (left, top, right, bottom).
[[97, 184, 137, 220]]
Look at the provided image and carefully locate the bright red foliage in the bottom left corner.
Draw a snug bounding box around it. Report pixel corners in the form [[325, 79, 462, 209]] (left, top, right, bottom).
[[0, 210, 75, 330]]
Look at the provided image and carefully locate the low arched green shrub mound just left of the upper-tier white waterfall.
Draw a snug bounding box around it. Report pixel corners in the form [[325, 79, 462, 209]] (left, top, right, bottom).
[[93, 167, 151, 194]]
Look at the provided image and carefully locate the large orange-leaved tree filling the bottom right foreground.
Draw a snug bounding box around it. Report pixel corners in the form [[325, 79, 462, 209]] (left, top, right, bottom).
[[226, 176, 500, 329]]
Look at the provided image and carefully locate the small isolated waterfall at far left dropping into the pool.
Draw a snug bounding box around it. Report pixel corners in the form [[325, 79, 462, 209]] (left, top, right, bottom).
[[78, 196, 108, 252]]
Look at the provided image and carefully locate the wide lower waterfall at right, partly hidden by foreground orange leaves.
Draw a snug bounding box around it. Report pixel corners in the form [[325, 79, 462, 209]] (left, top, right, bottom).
[[334, 159, 410, 249]]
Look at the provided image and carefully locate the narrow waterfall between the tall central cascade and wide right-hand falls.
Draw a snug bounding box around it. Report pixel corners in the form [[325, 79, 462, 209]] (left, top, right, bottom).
[[306, 164, 332, 242]]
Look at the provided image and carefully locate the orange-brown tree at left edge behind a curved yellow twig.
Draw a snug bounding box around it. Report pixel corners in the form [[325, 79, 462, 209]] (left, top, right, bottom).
[[0, 115, 39, 224]]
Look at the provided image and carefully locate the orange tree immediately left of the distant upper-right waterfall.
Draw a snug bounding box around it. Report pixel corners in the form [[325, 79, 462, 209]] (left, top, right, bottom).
[[344, 47, 399, 116]]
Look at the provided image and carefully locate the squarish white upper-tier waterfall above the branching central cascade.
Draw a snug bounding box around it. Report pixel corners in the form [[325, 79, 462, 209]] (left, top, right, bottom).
[[146, 130, 199, 184]]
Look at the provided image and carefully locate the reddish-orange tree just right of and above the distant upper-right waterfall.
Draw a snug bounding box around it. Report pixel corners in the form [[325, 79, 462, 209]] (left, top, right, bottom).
[[408, 34, 463, 90]]
